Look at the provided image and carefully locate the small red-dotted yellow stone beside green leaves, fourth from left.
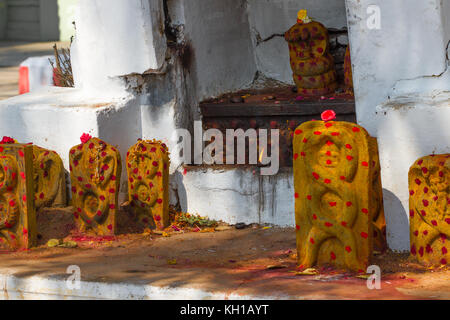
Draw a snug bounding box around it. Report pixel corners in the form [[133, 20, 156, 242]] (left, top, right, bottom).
[[127, 140, 170, 230]]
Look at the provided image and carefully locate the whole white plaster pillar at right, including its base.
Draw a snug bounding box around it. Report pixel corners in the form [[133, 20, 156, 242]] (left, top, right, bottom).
[[346, 0, 450, 251]]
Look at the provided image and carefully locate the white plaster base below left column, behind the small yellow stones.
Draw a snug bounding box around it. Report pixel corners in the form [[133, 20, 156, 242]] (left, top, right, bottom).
[[0, 87, 141, 199]]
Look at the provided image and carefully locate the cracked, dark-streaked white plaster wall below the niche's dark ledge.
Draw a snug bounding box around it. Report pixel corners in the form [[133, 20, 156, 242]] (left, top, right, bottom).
[[171, 168, 295, 227]]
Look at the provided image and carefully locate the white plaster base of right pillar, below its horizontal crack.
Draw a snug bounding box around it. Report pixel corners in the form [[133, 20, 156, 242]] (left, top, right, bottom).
[[374, 94, 450, 251]]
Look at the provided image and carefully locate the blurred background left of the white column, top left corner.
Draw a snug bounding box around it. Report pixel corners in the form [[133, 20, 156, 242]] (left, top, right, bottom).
[[0, 0, 78, 100]]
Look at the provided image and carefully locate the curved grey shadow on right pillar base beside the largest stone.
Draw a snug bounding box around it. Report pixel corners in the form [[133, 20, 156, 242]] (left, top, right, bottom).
[[383, 189, 410, 251]]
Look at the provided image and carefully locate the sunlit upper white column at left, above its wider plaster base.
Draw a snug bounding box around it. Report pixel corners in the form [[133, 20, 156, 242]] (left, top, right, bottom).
[[72, 0, 167, 94]]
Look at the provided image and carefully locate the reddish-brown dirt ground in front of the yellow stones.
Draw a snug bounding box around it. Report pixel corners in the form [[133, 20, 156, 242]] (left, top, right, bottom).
[[0, 208, 450, 299]]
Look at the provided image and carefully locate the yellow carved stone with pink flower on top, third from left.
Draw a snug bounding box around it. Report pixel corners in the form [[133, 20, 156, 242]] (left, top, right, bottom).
[[69, 137, 122, 235]]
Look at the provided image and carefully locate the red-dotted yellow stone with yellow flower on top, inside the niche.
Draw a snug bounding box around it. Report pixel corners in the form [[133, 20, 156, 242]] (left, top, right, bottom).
[[284, 10, 337, 95]]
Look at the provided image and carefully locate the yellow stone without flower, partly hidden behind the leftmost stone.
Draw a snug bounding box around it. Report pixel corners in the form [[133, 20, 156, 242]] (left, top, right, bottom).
[[33, 146, 67, 211]]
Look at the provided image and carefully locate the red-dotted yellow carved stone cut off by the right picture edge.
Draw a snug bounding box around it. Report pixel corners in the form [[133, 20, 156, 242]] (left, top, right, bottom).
[[409, 154, 450, 265]]
